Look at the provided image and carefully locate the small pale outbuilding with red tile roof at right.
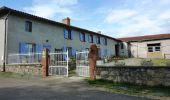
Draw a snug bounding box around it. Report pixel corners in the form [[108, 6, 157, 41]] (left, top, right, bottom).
[[119, 33, 170, 59]]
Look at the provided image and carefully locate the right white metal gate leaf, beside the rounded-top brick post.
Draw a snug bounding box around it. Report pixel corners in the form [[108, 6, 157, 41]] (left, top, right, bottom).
[[76, 51, 89, 77]]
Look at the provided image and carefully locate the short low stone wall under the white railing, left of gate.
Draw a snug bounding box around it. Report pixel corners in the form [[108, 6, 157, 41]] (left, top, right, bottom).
[[0, 64, 42, 76]]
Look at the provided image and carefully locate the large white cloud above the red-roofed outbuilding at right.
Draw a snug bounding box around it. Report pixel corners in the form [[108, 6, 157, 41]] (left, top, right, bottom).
[[104, 0, 170, 37]]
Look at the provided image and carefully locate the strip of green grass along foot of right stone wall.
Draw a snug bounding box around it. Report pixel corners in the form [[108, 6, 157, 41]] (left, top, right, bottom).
[[86, 79, 170, 97]]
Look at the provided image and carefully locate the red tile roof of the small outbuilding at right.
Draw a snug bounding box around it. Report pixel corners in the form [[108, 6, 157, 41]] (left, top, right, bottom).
[[118, 33, 170, 42]]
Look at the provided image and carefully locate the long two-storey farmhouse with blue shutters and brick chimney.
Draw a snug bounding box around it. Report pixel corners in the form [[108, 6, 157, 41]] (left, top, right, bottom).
[[0, 7, 119, 64]]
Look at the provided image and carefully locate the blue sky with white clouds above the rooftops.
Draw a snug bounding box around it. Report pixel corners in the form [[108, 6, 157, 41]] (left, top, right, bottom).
[[0, 0, 170, 38]]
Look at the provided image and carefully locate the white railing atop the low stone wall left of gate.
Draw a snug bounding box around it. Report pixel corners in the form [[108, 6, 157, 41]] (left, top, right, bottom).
[[7, 53, 42, 64]]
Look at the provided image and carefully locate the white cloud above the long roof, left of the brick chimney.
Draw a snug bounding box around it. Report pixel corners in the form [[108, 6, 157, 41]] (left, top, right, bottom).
[[24, 0, 78, 18]]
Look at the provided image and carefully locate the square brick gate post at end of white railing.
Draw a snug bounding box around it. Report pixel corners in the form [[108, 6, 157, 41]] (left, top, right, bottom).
[[41, 49, 49, 78]]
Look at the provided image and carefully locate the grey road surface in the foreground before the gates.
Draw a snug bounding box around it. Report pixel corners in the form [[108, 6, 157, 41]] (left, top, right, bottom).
[[0, 77, 151, 100]]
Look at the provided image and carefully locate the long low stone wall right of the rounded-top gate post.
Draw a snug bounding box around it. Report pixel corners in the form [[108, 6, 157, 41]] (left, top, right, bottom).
[[96, 66, 170, 86]]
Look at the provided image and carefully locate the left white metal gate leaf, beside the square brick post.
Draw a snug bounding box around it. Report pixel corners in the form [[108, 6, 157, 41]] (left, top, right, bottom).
[[49, 51, 68, 77]]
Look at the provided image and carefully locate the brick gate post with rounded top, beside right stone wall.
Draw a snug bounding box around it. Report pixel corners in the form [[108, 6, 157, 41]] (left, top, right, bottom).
[[88, 44, 98, 80]]
